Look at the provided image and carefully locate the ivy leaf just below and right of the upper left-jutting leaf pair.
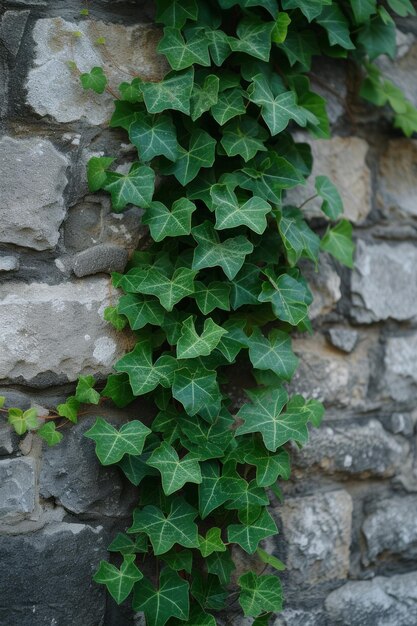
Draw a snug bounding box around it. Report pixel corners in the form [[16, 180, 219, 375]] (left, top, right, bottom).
[[142, 198, 196, 241]]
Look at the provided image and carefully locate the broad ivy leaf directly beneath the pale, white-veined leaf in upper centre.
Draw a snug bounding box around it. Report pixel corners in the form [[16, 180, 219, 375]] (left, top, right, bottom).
[[191, 221, 253, 280]]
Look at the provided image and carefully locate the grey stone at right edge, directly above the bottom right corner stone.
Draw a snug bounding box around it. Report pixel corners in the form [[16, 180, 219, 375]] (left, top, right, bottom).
[[362, 496, 417, 565]]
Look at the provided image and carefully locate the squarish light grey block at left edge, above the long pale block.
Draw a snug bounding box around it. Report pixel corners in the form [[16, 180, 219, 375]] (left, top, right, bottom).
[[0, 137, 68, 250]]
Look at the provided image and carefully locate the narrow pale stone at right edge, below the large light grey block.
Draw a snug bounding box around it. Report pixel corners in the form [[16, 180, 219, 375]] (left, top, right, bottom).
[[383, 333, 417, 406]]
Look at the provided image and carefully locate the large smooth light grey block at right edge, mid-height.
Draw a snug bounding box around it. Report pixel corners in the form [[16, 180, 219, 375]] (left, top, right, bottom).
[[351, 241, 417, 324]]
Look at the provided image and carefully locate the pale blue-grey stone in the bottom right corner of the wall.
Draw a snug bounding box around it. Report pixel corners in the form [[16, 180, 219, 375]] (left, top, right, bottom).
[[326, 572, 417, 626]]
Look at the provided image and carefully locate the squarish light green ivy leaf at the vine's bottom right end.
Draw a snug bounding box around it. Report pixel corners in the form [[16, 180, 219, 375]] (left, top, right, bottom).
[[238, 572, 283, 617]]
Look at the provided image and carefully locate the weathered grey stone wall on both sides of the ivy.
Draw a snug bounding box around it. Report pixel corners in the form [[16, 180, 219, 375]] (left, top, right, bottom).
[[0, 0, 417, 626]]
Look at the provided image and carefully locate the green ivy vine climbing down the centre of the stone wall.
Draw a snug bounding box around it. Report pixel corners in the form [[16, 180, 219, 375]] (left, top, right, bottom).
[[3, 0, 417, 626]]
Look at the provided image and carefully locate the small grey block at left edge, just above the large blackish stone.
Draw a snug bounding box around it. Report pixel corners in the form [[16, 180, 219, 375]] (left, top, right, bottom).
[[0, 457, 36, 522]]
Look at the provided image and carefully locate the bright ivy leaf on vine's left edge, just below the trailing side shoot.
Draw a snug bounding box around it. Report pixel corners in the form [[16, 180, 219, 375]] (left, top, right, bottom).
[[84, 417, 151, 465]]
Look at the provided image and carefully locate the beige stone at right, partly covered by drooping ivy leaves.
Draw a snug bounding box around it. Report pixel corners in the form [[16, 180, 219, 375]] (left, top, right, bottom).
[[287, 137, 371, 224]]
